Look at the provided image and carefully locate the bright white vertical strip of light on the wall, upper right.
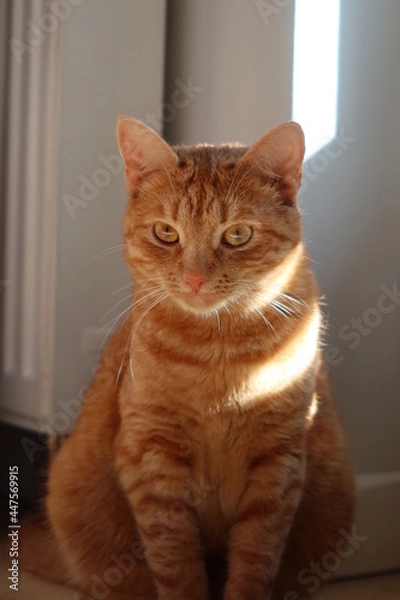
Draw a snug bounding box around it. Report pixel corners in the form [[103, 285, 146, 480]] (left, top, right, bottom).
[[292, 0, 340, 159]]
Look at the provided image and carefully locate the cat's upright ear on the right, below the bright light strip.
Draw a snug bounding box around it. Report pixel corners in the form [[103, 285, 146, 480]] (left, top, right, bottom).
[[239, 122, 305, 203]]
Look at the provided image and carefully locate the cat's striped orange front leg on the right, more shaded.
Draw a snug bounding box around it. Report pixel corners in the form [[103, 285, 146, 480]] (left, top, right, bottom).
[[223, 450, 305, 600]]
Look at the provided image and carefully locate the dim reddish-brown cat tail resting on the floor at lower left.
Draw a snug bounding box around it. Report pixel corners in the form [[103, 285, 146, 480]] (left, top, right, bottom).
[[18, 513, 70, 585]]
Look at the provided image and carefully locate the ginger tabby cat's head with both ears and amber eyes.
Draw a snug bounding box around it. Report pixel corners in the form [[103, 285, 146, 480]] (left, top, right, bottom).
[[117, 117, 304, 314]]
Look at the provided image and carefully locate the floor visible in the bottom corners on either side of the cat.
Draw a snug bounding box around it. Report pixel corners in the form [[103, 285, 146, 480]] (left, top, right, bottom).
[[0, 562, 400, 600]]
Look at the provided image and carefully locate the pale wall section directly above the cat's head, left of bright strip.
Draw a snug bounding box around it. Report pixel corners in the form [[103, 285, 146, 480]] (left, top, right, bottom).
[[165, 0, 293, 144]]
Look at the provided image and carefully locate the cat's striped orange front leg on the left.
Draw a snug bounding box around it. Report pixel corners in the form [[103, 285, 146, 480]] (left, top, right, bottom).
[[116, 424, 208, 600]]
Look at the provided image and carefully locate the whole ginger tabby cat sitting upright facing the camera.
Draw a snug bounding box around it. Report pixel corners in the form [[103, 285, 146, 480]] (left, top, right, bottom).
[[22, 117, 354, 600]]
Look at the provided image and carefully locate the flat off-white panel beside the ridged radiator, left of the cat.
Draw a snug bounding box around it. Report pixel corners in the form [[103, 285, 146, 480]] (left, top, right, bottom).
[[54, 0, 165, 427]]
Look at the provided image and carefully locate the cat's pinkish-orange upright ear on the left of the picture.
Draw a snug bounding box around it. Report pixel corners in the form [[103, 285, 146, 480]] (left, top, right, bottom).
[[117, 117, 178, 194]]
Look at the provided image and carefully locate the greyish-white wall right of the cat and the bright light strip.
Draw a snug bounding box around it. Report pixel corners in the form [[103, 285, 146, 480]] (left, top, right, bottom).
[[304, 0, 400, 472]]
